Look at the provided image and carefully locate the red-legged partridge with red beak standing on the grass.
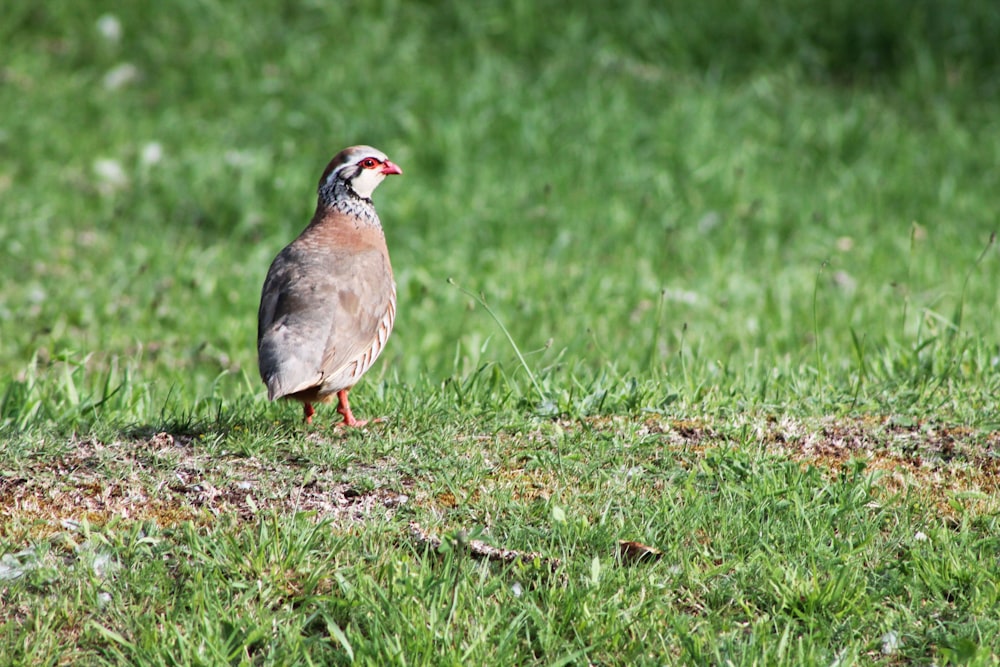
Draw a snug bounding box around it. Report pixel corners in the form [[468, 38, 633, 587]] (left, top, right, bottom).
[[257, 146, 403, 427]]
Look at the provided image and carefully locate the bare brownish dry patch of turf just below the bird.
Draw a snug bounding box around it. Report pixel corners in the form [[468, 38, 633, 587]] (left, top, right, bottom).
[[0, 433, 407, 536]]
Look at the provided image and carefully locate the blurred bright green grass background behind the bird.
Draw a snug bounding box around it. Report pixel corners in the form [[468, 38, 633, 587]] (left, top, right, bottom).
[[0, 0, 1000, 427]]
